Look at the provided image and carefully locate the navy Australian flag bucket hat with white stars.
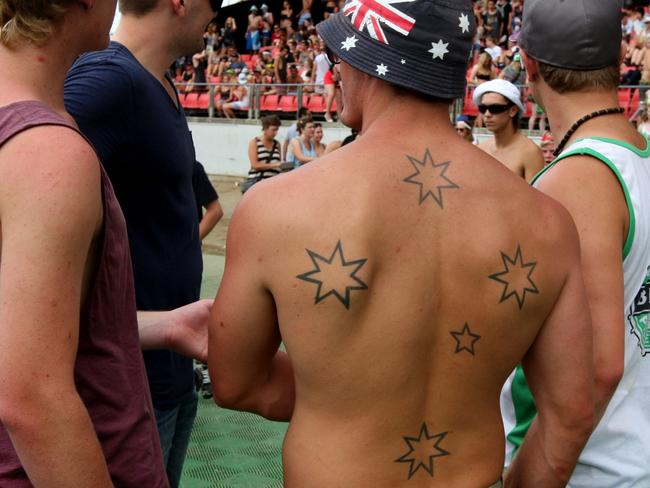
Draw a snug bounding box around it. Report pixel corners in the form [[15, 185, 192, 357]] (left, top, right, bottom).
[[316, 0, 476, 100]]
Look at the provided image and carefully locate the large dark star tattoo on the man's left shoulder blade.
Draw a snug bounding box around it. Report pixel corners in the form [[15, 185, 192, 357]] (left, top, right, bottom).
[[296, 240, 368, 310]]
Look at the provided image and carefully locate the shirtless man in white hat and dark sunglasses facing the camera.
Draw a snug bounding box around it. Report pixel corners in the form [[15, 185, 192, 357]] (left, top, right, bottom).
[[473, 80, 544, 181]]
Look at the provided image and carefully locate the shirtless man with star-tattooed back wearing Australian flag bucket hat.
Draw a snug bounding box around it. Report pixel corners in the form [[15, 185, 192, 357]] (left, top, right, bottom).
[[209, 0, 593, 488]]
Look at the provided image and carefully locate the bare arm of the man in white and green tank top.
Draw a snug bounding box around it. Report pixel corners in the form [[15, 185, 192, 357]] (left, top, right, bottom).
[[539, 156, 629, 421]]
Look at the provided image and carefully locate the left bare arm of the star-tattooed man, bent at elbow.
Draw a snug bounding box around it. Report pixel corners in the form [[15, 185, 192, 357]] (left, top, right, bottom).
[[208, 193, 295, 421]]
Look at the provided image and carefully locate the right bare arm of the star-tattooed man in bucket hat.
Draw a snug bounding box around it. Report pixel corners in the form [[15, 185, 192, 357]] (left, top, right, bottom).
[[505, 211, 594, 488]]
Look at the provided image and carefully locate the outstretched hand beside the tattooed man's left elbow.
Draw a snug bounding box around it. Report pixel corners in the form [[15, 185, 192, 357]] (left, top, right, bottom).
[[167, 300, 213, 362]]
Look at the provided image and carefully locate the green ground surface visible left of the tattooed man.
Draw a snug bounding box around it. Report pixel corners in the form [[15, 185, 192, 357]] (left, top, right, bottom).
[[181, 254, 287, 488]]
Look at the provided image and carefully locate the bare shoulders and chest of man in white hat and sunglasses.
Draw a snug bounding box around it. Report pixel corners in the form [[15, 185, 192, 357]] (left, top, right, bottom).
[[479, 132, 544, 181]]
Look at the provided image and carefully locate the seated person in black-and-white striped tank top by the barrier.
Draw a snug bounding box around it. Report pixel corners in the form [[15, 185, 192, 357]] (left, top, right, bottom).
[[242, 115, 282, 193]]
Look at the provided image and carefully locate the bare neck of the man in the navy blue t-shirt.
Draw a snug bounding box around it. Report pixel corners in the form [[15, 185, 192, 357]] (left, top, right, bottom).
[[113, 14, 176, 83]]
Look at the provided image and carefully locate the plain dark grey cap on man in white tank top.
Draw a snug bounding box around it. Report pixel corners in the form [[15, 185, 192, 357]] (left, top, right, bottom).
[[519, 0, 623, 71]]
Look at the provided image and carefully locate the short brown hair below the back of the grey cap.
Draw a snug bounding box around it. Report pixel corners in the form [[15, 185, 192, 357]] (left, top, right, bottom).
[[537, 61, 620, 93]]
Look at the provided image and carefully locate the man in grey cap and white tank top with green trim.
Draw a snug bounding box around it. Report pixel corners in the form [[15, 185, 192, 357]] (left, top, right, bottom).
[[502, 0, 650, 488]]
